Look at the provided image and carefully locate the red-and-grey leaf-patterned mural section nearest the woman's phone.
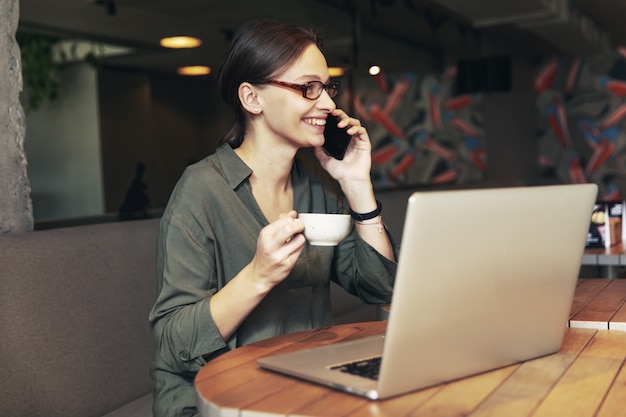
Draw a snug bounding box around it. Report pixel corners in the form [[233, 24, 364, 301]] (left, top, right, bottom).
[[353, 67, 486, 188]]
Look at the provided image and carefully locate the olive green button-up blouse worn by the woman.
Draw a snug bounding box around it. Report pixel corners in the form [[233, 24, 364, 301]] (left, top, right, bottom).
[[149, 144, 396, 417]]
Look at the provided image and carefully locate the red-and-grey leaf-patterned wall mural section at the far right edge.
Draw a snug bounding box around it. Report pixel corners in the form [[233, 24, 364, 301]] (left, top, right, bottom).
[[534, 49, 626, 200]]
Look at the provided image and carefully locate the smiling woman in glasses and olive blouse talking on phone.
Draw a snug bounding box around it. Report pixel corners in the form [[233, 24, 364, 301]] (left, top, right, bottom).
[[150, 21, 396, 417]]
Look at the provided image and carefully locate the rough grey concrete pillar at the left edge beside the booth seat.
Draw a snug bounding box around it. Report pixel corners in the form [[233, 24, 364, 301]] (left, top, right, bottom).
[[0, 0, 34, 235]]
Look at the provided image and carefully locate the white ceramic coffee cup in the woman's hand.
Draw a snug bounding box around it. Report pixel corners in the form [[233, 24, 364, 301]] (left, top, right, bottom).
[[298, 213, 352, 246]]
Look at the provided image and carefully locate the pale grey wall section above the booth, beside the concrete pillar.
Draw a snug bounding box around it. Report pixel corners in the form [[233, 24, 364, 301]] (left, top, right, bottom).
[[25, 64, 104, 221]]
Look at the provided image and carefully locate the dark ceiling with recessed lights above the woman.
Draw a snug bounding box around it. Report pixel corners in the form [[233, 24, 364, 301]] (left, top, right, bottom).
[[20, 0, 626, 72]]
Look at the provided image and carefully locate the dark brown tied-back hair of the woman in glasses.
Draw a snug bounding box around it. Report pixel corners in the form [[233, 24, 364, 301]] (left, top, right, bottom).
[[217, 19, 323, 148]]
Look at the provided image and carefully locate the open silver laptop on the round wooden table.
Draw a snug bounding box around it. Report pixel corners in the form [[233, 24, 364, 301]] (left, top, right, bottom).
[[258, 184, 597, 399]]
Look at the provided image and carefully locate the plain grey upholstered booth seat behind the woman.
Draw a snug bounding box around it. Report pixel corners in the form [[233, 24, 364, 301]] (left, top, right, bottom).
[[0, 218, 376, 417]]
